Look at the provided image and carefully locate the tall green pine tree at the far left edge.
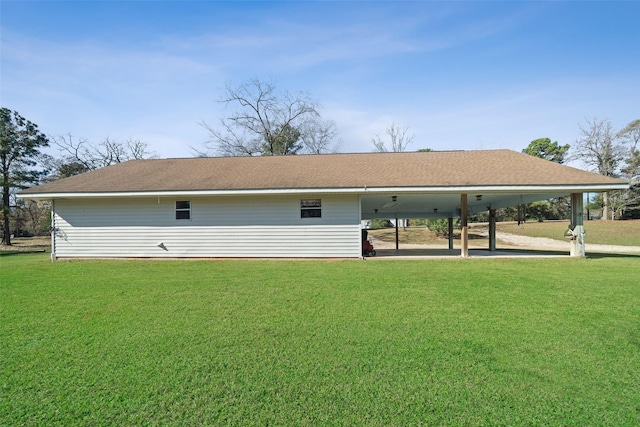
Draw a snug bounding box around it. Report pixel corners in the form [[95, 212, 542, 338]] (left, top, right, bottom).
[[0, 107, 49, 245]]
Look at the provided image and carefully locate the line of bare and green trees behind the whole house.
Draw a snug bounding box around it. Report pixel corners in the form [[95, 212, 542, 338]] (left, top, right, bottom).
[[0, 79, 640, 245]]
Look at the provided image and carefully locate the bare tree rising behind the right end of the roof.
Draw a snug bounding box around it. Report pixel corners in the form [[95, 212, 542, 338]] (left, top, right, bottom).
[[573, 118, 626, 219]]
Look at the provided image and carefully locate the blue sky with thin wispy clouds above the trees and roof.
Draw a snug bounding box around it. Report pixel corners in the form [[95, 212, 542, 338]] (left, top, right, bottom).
[[0, 0, 640, 157]]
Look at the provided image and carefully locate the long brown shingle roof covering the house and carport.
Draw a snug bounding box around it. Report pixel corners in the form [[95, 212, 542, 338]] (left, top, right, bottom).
[[22, 150, 624, 195]]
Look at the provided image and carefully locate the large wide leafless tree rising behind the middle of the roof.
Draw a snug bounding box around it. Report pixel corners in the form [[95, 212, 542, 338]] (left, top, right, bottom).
[[194, 79, 335, 156]]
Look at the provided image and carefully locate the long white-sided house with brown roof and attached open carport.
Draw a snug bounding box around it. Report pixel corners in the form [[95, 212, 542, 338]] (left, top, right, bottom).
[[19, 150, 627, 259]]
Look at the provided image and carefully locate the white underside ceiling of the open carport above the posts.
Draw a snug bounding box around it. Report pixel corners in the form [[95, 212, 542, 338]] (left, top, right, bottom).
[[361, 193, 568, 219]]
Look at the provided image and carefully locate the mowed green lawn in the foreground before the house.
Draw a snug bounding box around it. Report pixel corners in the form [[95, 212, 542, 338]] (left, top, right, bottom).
[[0, 255, 640, 426]]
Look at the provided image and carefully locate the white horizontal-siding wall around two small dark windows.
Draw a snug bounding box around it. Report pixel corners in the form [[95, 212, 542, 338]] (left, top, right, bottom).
[[53, 195, 361, 258]]
